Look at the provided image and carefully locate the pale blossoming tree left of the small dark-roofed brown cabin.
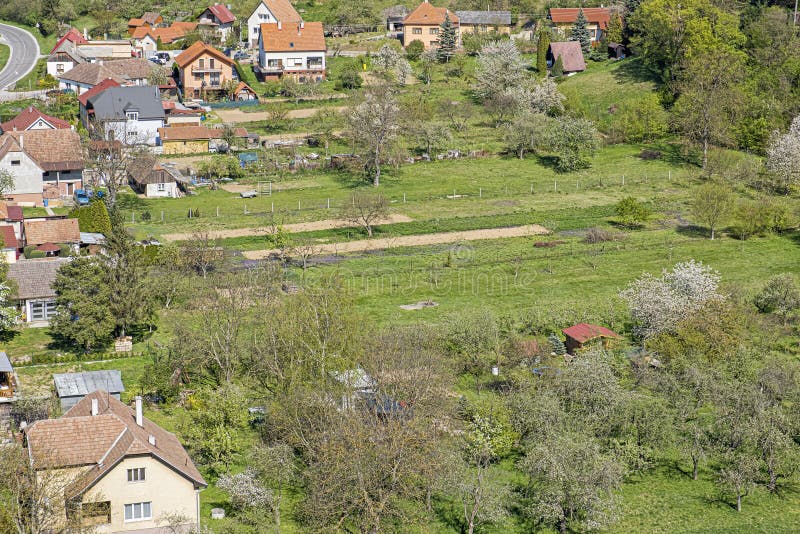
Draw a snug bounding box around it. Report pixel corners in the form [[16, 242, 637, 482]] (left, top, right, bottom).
[[473, 41, 527, 100]]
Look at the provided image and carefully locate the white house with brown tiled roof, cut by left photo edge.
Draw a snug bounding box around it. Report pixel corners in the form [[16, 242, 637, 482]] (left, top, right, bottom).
[[0, 129, 84, 205]]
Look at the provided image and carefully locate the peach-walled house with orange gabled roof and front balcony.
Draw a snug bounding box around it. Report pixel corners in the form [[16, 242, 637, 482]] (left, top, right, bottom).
[[175, 41, 238, 98]]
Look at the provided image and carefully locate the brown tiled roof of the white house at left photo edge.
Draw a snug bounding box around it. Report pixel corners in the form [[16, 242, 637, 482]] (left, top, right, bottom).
[[0, 130, 83, 171]]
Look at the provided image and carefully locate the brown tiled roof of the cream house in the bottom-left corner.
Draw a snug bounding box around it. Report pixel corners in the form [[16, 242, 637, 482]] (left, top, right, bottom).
[[25, 390, 206, 497]]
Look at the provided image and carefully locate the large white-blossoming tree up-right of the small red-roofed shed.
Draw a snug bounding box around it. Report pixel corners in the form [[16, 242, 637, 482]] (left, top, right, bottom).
[[620, 260, 724, 338]]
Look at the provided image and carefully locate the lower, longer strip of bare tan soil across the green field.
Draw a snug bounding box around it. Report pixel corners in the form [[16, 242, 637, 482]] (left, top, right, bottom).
[[242, 224, 550, 260]]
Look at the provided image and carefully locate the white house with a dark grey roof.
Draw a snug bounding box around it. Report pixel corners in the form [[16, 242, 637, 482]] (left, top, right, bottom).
[[81, 86, 165, 146]]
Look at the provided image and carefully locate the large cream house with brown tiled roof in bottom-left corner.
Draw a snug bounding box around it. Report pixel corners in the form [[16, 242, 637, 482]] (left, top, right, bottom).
[[23, 390, 206, 533]]
